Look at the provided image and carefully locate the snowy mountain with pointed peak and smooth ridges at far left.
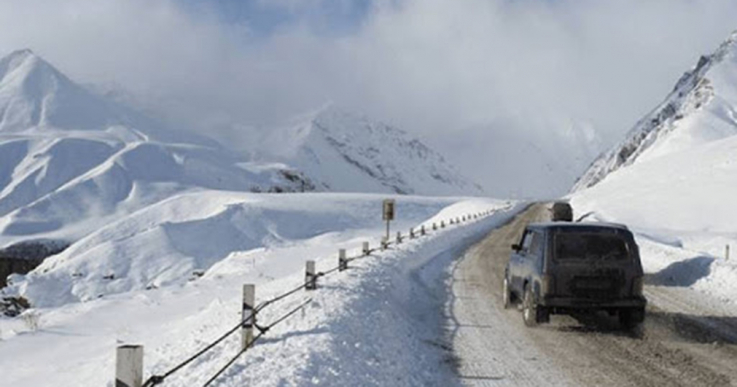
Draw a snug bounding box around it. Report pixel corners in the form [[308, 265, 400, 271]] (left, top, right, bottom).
[[0, 50, 310, 246]]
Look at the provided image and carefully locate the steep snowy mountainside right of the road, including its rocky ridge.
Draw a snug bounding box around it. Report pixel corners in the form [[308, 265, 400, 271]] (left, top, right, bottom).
[[571, 32, 737, 305]]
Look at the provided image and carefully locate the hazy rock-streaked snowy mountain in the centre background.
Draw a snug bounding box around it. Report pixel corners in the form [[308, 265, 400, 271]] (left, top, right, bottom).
[[247, 105, 482, 195]]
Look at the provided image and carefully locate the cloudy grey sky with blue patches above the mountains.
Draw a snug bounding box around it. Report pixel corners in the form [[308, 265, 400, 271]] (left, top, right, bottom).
[[0, 0, 737, 196]]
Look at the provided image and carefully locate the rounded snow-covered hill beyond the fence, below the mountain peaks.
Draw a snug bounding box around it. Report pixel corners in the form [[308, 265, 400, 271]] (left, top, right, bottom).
[[6, 191, 478, 307]]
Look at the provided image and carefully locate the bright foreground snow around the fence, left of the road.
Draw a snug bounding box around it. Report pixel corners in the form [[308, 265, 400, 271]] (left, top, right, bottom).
[[0, 195, 509, 386]]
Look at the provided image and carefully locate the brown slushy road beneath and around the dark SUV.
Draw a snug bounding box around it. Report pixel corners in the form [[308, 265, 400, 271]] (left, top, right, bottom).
[[448, 205, 737, 386]]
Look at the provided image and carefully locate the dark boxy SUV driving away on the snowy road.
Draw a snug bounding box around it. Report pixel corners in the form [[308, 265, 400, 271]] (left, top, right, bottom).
[[503, 222, 646, 329]]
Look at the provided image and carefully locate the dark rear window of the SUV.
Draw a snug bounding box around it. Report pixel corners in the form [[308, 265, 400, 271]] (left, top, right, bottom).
[[553, 231, 630, 261]]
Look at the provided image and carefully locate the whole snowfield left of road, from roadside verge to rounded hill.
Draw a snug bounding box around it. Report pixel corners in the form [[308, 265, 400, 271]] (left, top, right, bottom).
[[0, 197, 514, 386]]
